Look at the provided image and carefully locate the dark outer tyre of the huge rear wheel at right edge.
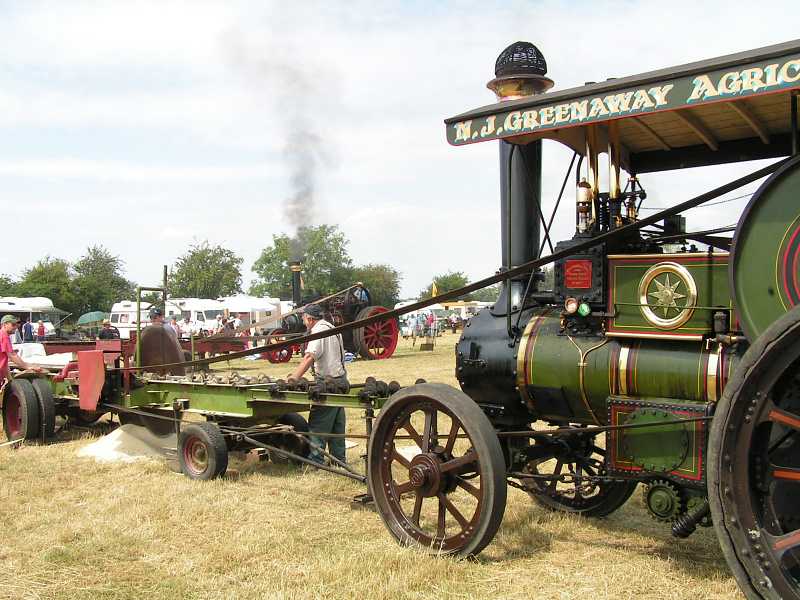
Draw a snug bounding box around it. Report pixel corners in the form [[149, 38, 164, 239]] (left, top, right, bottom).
[[708, 306, 800, 600]]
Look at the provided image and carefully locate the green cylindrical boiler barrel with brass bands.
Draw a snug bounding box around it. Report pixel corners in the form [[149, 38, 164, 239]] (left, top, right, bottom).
[[518, 316, 739, 424]]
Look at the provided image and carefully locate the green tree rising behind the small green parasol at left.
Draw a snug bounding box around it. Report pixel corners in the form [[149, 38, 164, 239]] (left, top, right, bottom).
[[72, 246, 136, 314]]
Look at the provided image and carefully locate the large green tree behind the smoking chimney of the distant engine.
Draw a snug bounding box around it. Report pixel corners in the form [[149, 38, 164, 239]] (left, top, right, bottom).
[[250, 225, 353, 299]]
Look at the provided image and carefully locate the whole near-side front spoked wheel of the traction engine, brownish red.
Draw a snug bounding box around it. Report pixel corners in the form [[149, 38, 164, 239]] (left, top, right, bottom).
[[368, 383, 506, 556]]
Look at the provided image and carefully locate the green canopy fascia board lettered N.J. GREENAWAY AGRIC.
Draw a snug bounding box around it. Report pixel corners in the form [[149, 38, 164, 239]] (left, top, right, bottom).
[[447, 55, 800, 146]]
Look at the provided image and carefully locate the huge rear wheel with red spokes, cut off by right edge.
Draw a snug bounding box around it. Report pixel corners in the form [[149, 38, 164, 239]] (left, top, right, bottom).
[[708, 307, 800, 600]]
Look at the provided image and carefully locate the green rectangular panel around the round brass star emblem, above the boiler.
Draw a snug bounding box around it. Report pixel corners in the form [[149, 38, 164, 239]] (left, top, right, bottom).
[[608, 253, 731, 336]]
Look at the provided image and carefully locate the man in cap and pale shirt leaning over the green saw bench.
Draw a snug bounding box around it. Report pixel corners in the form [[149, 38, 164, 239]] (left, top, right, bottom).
[[289, 304, 350, 463]]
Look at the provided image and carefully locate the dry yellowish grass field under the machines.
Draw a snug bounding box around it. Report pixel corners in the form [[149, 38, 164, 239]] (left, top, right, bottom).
[[0, 334, 740, 600]]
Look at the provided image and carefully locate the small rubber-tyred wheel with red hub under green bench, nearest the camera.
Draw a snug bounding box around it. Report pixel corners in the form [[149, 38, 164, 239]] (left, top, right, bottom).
[[178, 423, 228, 480]]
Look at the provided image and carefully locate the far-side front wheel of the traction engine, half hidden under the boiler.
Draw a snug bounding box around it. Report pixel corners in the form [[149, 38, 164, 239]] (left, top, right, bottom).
[[522, 426, 637, 517]]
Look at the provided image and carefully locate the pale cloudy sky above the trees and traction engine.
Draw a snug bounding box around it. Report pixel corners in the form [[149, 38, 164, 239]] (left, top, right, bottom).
[[0, 0, 800, 297]]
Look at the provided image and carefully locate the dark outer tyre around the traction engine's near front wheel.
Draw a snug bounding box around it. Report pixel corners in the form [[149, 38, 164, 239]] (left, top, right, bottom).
[[367, 383, 508, 556]]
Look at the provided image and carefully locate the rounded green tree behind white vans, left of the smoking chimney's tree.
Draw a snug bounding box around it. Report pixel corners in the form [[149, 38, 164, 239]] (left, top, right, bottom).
[[168, 240, 243, 298]]
